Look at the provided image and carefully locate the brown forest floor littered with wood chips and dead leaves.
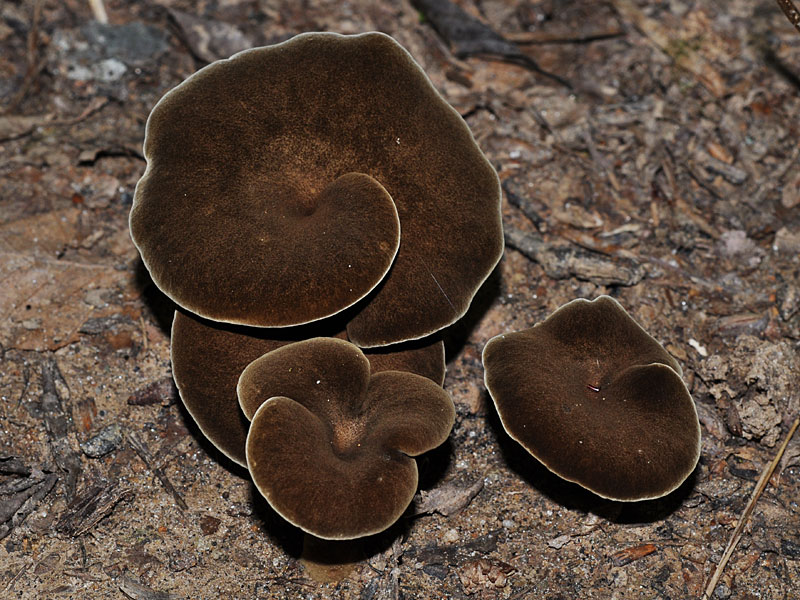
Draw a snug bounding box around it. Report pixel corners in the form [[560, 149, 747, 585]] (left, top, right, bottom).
[[0, 0, 800, 600]]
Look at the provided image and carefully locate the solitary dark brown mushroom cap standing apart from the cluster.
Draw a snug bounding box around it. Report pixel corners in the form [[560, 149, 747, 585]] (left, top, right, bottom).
[[483, 296, 700, 501]]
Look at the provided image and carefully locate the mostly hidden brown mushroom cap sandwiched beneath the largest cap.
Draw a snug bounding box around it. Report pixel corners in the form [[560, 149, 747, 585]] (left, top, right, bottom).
[[171, 310, 445, 466]]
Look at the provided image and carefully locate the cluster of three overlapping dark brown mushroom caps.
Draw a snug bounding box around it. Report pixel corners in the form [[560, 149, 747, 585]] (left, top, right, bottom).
[[130, 33, 503, 539]]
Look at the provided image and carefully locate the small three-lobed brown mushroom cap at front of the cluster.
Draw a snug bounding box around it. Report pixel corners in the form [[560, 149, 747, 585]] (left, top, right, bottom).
[[238, 338, 455, 540]]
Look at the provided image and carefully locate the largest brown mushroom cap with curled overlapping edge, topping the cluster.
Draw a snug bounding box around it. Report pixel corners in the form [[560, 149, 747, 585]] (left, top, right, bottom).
[[130, 33, 503, 347]]
